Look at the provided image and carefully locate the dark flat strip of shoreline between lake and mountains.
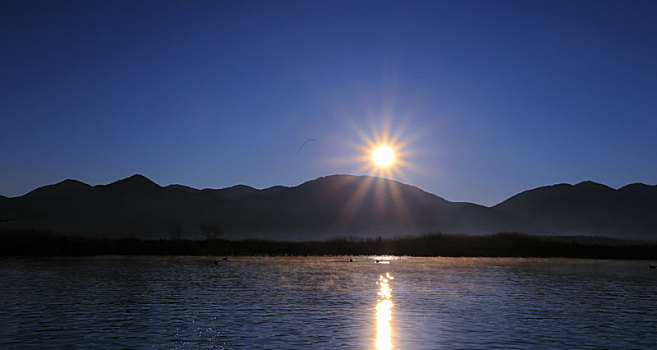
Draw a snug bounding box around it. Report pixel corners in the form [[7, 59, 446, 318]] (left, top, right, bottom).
[[0, 230, 657, 260]]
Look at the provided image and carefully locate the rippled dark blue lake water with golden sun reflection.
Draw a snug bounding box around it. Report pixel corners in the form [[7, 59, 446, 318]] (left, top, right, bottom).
[[0, 257, 657, 349]]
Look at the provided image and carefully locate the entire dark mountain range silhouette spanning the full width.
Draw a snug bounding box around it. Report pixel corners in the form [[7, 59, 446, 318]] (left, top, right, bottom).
[[0, 175, 657, 240]]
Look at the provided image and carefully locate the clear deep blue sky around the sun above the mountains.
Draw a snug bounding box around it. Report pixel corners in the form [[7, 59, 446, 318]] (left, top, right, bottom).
[[0, 0, 657, 205]]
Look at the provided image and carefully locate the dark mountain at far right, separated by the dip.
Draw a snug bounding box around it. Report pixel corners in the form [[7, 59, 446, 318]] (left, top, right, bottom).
[[493, 181, 657, 239]]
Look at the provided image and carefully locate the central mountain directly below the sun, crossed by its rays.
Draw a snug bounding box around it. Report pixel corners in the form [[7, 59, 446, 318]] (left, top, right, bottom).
[[215, 175, 515, 237]]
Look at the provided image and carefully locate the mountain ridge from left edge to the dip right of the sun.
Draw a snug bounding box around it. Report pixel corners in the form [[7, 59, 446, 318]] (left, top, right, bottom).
[[0, 175, 525, 239]]
